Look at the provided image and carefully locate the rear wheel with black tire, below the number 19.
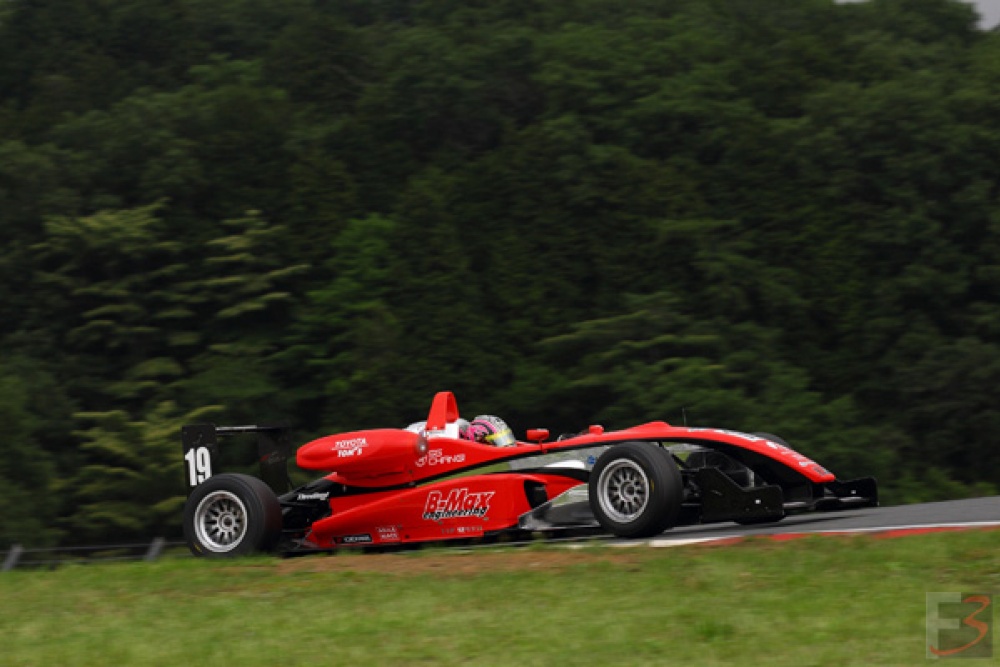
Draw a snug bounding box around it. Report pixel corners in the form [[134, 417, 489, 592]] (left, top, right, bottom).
[[184, 473, 281, 558]]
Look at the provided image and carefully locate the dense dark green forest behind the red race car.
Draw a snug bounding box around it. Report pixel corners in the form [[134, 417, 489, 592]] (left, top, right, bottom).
[[0, 0, 1000, 546]]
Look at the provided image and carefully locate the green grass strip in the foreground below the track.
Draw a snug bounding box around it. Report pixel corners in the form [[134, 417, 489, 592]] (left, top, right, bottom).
[[0, 531, 1000, 667]]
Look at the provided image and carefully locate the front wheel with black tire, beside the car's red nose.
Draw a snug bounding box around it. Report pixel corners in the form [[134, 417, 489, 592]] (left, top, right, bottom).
[[588, 442, 684, 538]]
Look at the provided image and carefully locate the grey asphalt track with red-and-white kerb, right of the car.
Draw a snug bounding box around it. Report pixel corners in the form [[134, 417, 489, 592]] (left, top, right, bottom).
[[632, 496, 1000, 547]]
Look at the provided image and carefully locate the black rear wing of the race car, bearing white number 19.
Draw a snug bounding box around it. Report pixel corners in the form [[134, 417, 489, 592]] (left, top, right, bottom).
[[181, 424, 293, 495]]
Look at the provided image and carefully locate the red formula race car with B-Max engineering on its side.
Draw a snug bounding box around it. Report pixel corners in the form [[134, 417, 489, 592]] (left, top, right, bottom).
[[182, 392, 878, 557]]
